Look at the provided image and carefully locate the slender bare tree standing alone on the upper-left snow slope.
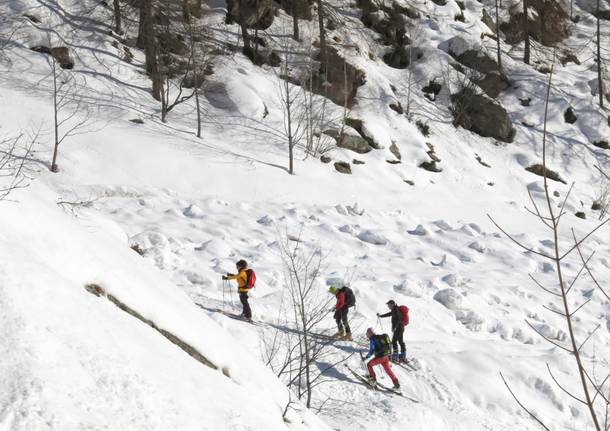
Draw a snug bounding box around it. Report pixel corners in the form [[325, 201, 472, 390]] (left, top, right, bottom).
[[49, 55, 91, 172]]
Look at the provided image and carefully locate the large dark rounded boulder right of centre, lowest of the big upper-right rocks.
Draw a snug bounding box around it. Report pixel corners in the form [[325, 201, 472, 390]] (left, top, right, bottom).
[[451, 88, 515, 142]]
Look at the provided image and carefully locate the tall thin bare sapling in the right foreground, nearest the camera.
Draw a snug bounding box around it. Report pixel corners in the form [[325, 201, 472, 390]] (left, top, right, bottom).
[[488, 62, 610, 431]]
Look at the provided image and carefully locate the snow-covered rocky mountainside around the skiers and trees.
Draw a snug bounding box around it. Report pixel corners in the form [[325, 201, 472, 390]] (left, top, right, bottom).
[[0, 0, 610, 431]]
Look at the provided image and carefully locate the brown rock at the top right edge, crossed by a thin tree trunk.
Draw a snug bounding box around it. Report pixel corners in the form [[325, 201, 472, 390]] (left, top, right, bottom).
[[500, 0, 571, 46]]
